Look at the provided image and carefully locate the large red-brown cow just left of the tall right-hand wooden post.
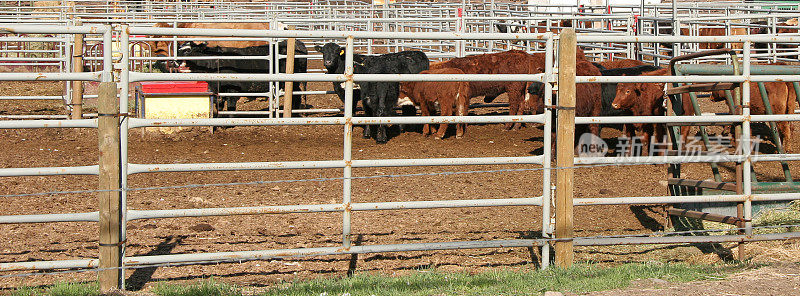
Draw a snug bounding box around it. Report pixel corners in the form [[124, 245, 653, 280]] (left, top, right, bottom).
[[430, 50, 543, 130]]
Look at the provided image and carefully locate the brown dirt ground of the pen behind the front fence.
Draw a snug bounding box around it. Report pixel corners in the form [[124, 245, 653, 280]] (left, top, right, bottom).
[[0, 60, 800, 295]]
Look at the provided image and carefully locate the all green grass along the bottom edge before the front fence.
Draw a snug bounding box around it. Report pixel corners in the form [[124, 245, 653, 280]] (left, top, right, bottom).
[[10, 262, 755, 296]]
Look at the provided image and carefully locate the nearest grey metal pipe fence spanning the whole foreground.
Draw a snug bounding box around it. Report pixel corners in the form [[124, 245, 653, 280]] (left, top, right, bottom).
[[0, 11, 800, 290]]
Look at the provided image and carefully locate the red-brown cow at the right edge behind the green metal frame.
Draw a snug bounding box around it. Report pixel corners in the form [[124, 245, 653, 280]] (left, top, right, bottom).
[[711, 82, 797, 153]]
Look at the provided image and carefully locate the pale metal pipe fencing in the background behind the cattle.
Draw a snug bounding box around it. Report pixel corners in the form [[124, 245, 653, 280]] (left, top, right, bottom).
[[0, 1, 800, 117]]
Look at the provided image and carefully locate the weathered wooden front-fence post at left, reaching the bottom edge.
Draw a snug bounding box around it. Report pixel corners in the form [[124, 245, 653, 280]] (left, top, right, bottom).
[[97, 82, 122, 293]]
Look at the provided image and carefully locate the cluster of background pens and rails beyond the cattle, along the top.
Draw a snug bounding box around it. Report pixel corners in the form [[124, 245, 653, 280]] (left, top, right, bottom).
[[0, 1, 800, 118]]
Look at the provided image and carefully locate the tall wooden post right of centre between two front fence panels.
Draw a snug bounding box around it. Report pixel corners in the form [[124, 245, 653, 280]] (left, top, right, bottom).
[[555, 28, 576, 268]]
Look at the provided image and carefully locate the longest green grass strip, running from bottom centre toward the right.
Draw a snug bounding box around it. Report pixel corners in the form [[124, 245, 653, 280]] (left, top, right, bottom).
[[264, 263, 747, 296]]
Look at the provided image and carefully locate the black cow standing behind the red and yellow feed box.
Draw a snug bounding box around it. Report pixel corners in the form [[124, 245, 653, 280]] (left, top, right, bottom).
[[178, 41, 308, 115]]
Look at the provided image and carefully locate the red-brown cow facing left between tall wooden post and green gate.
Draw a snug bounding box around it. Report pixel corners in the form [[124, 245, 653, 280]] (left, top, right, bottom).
[[611, 69, 694, 153]]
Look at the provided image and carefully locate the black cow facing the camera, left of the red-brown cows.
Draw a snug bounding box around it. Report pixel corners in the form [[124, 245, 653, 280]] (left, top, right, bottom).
[[314, 43, 430, 143]]
